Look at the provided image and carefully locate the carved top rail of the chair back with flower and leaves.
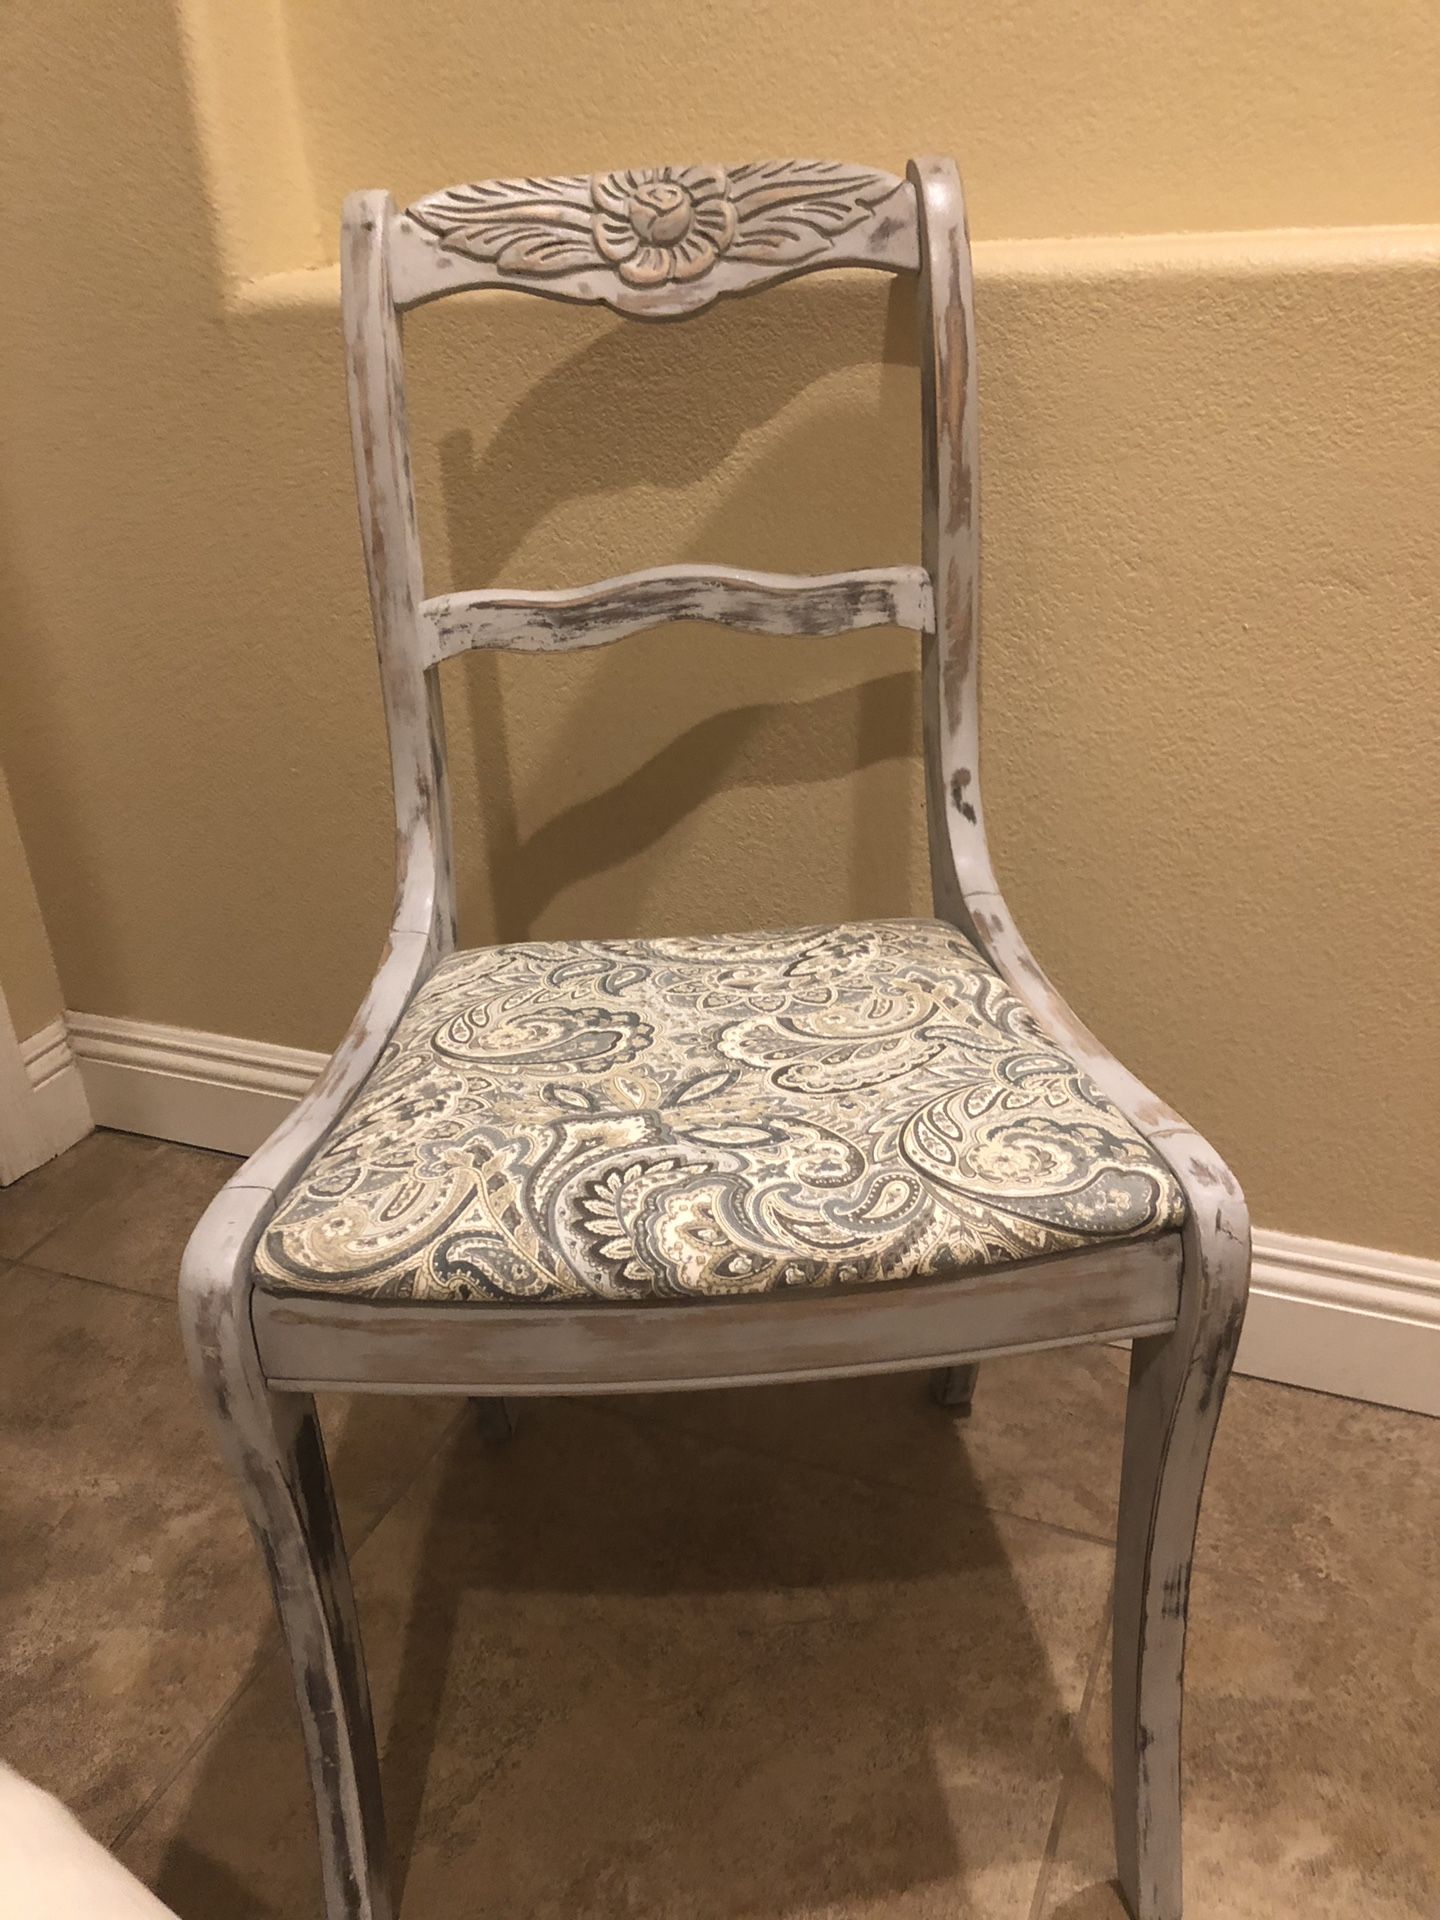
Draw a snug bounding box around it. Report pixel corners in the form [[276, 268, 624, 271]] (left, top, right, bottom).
[[394, 159, 916, 319]]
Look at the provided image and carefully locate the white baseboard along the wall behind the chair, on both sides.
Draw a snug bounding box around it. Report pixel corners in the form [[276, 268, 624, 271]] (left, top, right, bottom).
[[61, 1014, 1440, 1415]]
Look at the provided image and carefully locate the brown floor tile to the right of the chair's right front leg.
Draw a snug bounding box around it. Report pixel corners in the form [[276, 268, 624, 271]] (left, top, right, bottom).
[[1043, 1380, 1440, 1920]]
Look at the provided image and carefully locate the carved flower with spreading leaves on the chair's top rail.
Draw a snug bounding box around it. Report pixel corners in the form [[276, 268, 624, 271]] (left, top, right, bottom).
[[407, 159, 899, 288]]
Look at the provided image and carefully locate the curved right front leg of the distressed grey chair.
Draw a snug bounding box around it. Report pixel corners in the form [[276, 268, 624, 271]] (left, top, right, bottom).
[[1114, 1194, 1250, 1920]]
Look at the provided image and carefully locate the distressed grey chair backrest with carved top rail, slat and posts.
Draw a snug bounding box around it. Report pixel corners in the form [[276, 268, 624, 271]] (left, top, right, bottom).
[[342, 159, 995, 950]]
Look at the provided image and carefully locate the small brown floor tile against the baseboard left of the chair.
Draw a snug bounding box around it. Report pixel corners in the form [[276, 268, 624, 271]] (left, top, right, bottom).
[[27, 1140, 240, 1300]]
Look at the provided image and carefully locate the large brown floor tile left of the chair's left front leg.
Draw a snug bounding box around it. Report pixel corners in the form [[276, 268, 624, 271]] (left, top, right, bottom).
[[0, 1267, 455, 1843]]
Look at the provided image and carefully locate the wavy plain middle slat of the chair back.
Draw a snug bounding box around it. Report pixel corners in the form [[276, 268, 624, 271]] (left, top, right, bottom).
[[420, 566, 931, 662]]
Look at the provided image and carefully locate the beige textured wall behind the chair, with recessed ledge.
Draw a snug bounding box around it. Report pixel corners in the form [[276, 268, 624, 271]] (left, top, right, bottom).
[[0, 0, 1440, 1252]]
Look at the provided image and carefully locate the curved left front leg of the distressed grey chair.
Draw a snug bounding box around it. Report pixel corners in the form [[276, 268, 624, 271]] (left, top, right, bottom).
[[180, 1228, 392, 1920]]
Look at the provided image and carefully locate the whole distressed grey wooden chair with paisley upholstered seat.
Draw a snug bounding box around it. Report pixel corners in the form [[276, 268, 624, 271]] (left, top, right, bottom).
[[180, 159, 1250, 1920]]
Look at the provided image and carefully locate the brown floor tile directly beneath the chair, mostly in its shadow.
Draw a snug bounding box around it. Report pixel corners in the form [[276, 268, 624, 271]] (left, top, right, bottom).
[[123, 1402, 1110, 1920]]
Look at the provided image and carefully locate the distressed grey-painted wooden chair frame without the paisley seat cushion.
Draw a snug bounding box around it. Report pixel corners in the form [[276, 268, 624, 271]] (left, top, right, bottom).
[[180, 159, 1250, 1920]]
